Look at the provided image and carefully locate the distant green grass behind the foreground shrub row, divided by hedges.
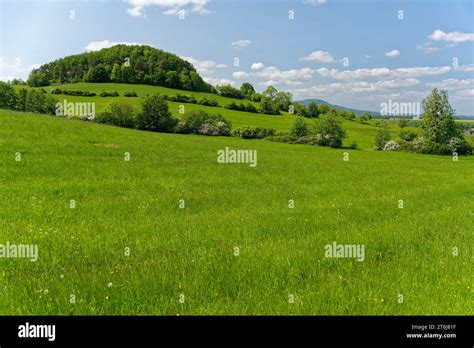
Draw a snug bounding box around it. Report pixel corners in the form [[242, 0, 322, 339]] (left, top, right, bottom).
[[32, 83, 414, 149]]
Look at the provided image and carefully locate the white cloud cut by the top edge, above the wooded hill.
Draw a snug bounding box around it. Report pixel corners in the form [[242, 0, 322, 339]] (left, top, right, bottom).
[[127, 0, 210, 17]]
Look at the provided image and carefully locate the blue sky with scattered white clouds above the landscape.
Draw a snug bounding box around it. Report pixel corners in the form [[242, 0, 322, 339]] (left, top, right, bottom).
[[0, 0, 474, 115]]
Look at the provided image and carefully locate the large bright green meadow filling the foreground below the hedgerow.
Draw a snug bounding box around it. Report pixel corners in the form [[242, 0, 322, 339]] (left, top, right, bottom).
[[0, 110, 474, 315]]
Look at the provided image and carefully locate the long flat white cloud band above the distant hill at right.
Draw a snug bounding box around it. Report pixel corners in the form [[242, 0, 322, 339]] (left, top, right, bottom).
[[316, 66, 452, 80]]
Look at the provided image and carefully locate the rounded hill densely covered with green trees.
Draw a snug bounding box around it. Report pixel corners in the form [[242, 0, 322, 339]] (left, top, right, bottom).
[[28, 45, 213, 92]]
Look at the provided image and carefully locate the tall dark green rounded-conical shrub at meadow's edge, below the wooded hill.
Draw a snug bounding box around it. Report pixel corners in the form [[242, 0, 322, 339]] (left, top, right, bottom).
[[137, 93, 178, 133]]
